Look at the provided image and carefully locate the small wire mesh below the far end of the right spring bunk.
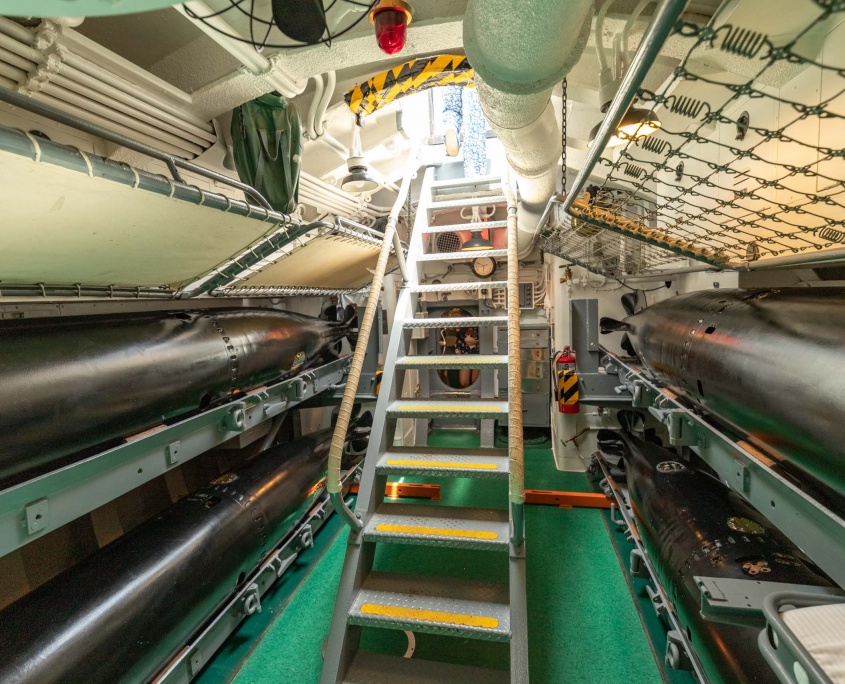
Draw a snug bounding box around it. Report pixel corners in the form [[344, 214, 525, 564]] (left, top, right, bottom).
[[540, 211, 679, 278]]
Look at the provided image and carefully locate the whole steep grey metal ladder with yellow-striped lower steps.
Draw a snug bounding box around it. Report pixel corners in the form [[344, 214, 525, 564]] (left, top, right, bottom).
[[321, 169, 528, 684]]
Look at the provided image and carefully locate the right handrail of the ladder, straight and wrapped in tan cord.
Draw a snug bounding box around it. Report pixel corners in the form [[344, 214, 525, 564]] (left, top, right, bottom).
[[502, 165, 525, 547]]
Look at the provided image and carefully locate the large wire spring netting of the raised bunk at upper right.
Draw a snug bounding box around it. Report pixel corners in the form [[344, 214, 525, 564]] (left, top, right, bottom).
[[570, 0, 845, 267]]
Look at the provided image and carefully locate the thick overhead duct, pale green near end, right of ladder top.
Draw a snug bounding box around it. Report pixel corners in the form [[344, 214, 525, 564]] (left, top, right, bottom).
[[463, 0, 593, 257]]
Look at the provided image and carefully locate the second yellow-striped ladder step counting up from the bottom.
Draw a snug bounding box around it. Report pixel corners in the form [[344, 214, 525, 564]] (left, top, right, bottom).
[[364, 503, 510, 551]]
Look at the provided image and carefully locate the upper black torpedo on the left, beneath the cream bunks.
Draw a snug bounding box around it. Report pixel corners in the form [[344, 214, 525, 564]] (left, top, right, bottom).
[[0, 309, 346, 480]]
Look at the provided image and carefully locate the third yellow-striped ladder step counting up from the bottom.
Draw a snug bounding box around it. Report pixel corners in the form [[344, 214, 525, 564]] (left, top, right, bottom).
[[376, 447, 510, 478]]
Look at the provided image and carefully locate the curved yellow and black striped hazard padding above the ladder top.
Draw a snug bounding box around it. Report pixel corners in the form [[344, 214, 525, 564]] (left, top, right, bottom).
[[345, 55, 475, 116]]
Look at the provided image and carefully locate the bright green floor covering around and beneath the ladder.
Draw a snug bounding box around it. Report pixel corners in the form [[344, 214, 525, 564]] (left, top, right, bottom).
[[223, 431, 661, 684]]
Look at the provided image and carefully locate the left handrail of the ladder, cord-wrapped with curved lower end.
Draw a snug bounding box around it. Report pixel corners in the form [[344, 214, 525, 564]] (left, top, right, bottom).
[[326, 143, 419, 532]]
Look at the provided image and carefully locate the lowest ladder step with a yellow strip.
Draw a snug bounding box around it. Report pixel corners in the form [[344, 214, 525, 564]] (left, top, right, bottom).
[[349, 572, 510, 641]]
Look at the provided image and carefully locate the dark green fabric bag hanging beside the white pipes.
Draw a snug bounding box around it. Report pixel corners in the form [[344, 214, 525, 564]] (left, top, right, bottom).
[[232, 93, 302, 214]]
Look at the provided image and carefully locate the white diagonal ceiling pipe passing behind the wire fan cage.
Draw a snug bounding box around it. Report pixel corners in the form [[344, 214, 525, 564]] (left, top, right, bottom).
[[174, 0, 308, 97]]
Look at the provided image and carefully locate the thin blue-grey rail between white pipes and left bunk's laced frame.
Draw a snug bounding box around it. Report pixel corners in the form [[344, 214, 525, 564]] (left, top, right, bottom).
[[0, 88, 274, 211]]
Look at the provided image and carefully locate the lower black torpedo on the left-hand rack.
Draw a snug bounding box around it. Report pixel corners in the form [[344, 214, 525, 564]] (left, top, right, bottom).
[[0, 431, 350, 684]]
